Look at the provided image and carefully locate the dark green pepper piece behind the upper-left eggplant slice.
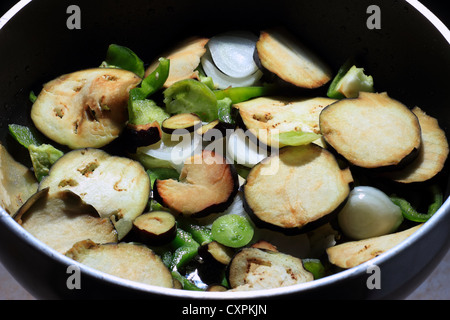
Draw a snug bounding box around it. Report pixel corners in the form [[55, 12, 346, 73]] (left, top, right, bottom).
[[102, 44, 145, 78]]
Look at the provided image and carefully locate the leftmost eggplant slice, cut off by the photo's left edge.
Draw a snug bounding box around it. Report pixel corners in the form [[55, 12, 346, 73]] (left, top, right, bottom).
[[0, 144, 38, 215]]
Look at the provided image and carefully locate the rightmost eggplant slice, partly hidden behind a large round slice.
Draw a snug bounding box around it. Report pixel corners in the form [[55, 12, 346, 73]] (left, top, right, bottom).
[[386, 107, 449, 183]]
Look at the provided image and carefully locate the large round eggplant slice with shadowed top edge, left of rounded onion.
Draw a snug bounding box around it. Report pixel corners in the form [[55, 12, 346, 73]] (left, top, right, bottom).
[[244, 144, 353, 232]]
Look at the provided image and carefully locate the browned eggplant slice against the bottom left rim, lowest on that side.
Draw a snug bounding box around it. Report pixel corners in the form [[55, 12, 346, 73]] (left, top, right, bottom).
[[66, 240, 173, 288]]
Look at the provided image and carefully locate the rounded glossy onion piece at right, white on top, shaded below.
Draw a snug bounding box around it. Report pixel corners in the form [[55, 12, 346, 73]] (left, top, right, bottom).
[[338, 186, 403, 240]]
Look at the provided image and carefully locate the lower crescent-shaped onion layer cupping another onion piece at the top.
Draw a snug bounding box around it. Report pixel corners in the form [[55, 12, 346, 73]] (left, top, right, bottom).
[[201, 51, 263, 89]]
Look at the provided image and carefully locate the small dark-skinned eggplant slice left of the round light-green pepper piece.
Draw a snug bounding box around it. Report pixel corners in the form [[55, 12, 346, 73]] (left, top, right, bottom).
[[133, 211, 177, 245]]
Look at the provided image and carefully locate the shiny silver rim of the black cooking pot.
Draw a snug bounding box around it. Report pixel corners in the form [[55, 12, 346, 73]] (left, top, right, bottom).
[[0, 0, 450, 300]]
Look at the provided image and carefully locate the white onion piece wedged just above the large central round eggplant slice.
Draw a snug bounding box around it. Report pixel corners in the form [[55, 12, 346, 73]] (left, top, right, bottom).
[[227, 129, 269, 168]]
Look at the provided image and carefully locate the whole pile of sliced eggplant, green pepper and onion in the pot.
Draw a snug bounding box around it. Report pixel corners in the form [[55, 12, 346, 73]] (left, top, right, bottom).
[[0, 29, 449, 291]]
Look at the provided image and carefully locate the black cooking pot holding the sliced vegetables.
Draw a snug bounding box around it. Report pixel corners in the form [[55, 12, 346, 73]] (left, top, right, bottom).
[[0, 0, 450, 299]]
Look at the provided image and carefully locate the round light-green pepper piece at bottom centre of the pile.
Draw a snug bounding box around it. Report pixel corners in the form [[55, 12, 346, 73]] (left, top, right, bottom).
[[211, 214, 254, 248]]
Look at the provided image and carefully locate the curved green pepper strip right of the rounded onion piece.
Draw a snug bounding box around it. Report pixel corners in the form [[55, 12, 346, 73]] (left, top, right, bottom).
[[390, 185, 444, 222]]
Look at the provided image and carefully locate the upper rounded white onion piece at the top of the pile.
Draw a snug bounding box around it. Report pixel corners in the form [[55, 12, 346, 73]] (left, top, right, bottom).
[[208, 31, 258, 78]]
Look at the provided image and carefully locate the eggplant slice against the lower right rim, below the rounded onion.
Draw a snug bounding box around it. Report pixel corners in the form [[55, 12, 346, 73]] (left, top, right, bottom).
[[326, 225, 422, 269]]
